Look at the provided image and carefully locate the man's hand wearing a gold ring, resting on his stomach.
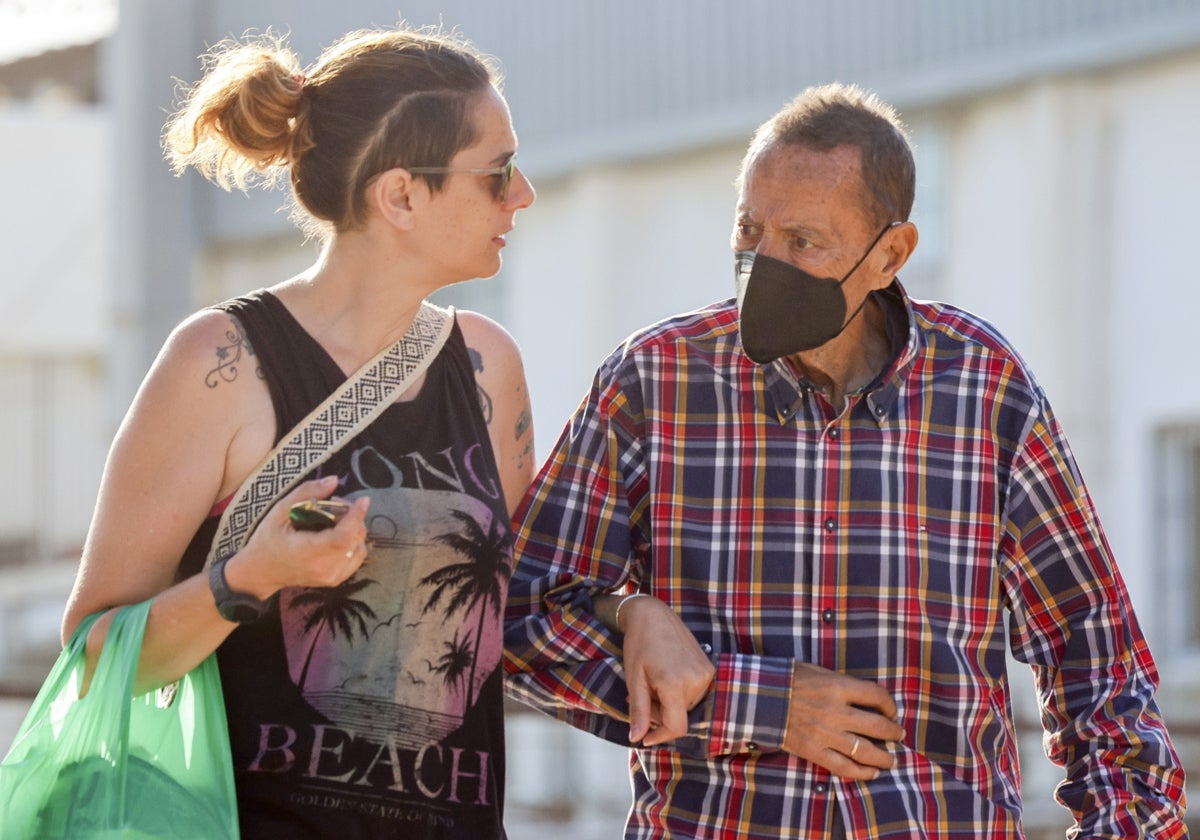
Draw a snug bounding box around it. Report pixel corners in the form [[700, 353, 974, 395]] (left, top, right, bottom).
[[784, 662, 904, 780]]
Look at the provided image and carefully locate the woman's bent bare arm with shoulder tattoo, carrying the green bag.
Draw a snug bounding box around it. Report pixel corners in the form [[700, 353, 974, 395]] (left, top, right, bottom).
[[62, 311, 365, 688]]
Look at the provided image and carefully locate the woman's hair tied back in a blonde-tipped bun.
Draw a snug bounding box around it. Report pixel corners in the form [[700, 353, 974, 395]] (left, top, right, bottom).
[[163, 24, 500, 234]]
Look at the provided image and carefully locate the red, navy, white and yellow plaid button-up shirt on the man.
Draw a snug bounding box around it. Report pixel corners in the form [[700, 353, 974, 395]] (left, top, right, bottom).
[[505, 283, 1187, 840]]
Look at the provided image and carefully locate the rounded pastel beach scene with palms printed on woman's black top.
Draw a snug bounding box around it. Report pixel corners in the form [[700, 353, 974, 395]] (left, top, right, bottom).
[[280, 488, 512, 750]]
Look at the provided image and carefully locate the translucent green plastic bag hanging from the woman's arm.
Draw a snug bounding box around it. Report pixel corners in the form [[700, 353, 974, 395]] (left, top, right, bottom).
[[0, 601, 238, 840]]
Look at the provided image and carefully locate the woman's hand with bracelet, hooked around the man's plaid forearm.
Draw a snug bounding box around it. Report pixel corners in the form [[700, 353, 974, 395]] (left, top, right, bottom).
[[598, 595, 716, 746]]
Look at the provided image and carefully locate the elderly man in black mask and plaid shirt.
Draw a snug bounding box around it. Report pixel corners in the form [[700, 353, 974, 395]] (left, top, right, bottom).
[[505, 85, 1187, 839]]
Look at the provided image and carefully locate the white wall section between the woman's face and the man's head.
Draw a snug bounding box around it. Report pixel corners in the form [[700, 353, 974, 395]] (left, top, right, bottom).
[[496, 146, 743, 457]]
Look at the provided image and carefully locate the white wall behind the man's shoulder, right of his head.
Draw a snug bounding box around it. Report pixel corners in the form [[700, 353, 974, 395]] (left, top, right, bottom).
[[946, 55, 1200, 659]]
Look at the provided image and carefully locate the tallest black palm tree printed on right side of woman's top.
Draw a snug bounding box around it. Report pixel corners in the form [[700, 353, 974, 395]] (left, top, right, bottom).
[[421, 510, 512, 708]]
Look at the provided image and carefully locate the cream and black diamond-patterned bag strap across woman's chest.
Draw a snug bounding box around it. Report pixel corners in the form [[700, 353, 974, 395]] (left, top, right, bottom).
[[204, 301, 454, 568]]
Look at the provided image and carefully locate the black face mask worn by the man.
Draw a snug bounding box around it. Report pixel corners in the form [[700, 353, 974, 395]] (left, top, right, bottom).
[[733, 222, 899, 365]]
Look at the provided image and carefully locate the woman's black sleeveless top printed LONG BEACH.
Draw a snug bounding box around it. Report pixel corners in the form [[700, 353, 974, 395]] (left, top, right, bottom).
[[181, 292, 512, 840]]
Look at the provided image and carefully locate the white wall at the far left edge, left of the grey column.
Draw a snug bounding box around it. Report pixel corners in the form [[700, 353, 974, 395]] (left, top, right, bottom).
[[0, 100, 112, 554]]
